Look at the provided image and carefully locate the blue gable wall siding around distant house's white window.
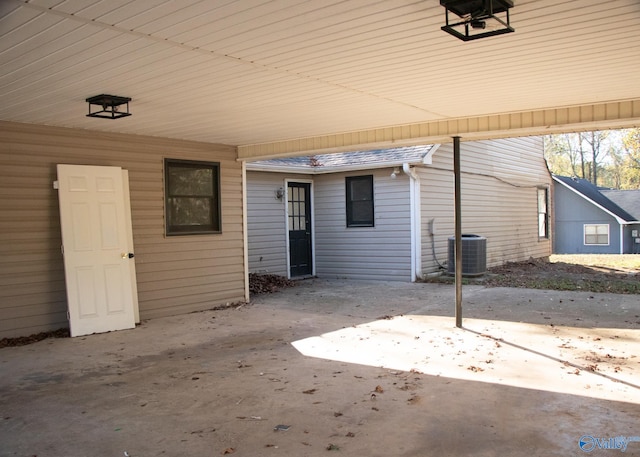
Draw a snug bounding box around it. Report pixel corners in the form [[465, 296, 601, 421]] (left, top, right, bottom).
[[554, 185, 620, 254]]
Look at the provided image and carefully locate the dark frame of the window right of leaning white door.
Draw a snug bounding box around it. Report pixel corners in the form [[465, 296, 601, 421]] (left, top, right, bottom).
[[164, 158, 222, 236]]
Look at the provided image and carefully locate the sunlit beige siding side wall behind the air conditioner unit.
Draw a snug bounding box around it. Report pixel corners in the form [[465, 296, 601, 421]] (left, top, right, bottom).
[[419, 137, 551, 273]]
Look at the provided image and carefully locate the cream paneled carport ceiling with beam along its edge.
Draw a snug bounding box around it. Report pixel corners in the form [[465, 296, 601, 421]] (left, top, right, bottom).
[[0, 0, 640, 158]]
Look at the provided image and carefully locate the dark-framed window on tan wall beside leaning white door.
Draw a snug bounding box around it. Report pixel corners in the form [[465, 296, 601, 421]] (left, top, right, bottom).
[[164, 159, 222, 235]]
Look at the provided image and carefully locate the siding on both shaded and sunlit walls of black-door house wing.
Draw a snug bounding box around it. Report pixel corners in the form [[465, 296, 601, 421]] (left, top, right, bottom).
[[247, 137, 551, 281]]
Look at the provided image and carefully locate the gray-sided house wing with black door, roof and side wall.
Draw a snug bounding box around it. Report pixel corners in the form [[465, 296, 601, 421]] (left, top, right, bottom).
[[247, 137, 551, 281]]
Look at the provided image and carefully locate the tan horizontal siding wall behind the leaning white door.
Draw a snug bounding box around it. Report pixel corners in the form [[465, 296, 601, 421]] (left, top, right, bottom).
[[0, 120, 245, 337]]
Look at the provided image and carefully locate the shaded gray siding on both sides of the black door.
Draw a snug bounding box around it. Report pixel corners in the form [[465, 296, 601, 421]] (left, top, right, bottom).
[[247, 169, 411, 281]]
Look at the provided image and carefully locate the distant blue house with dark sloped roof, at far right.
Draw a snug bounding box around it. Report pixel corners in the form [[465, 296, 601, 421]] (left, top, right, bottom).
[[553, 176, 640, 254]]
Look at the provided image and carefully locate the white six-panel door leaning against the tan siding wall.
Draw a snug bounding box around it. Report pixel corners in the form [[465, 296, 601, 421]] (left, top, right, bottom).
[[58, 165, 137, 336]]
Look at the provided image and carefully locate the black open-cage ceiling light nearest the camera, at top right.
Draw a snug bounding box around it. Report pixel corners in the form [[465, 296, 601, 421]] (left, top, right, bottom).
[[440, 0, 515, 41]]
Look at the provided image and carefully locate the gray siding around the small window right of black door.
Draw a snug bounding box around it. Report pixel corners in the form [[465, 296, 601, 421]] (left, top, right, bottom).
[[314, 169, 411, 281]]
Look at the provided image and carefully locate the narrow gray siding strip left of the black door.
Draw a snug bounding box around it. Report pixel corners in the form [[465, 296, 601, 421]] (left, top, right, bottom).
[[247, 171, 298, 276]]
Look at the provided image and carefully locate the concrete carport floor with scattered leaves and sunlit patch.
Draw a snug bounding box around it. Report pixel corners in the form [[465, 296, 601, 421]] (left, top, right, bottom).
[[0, 279, 640, 457]]
